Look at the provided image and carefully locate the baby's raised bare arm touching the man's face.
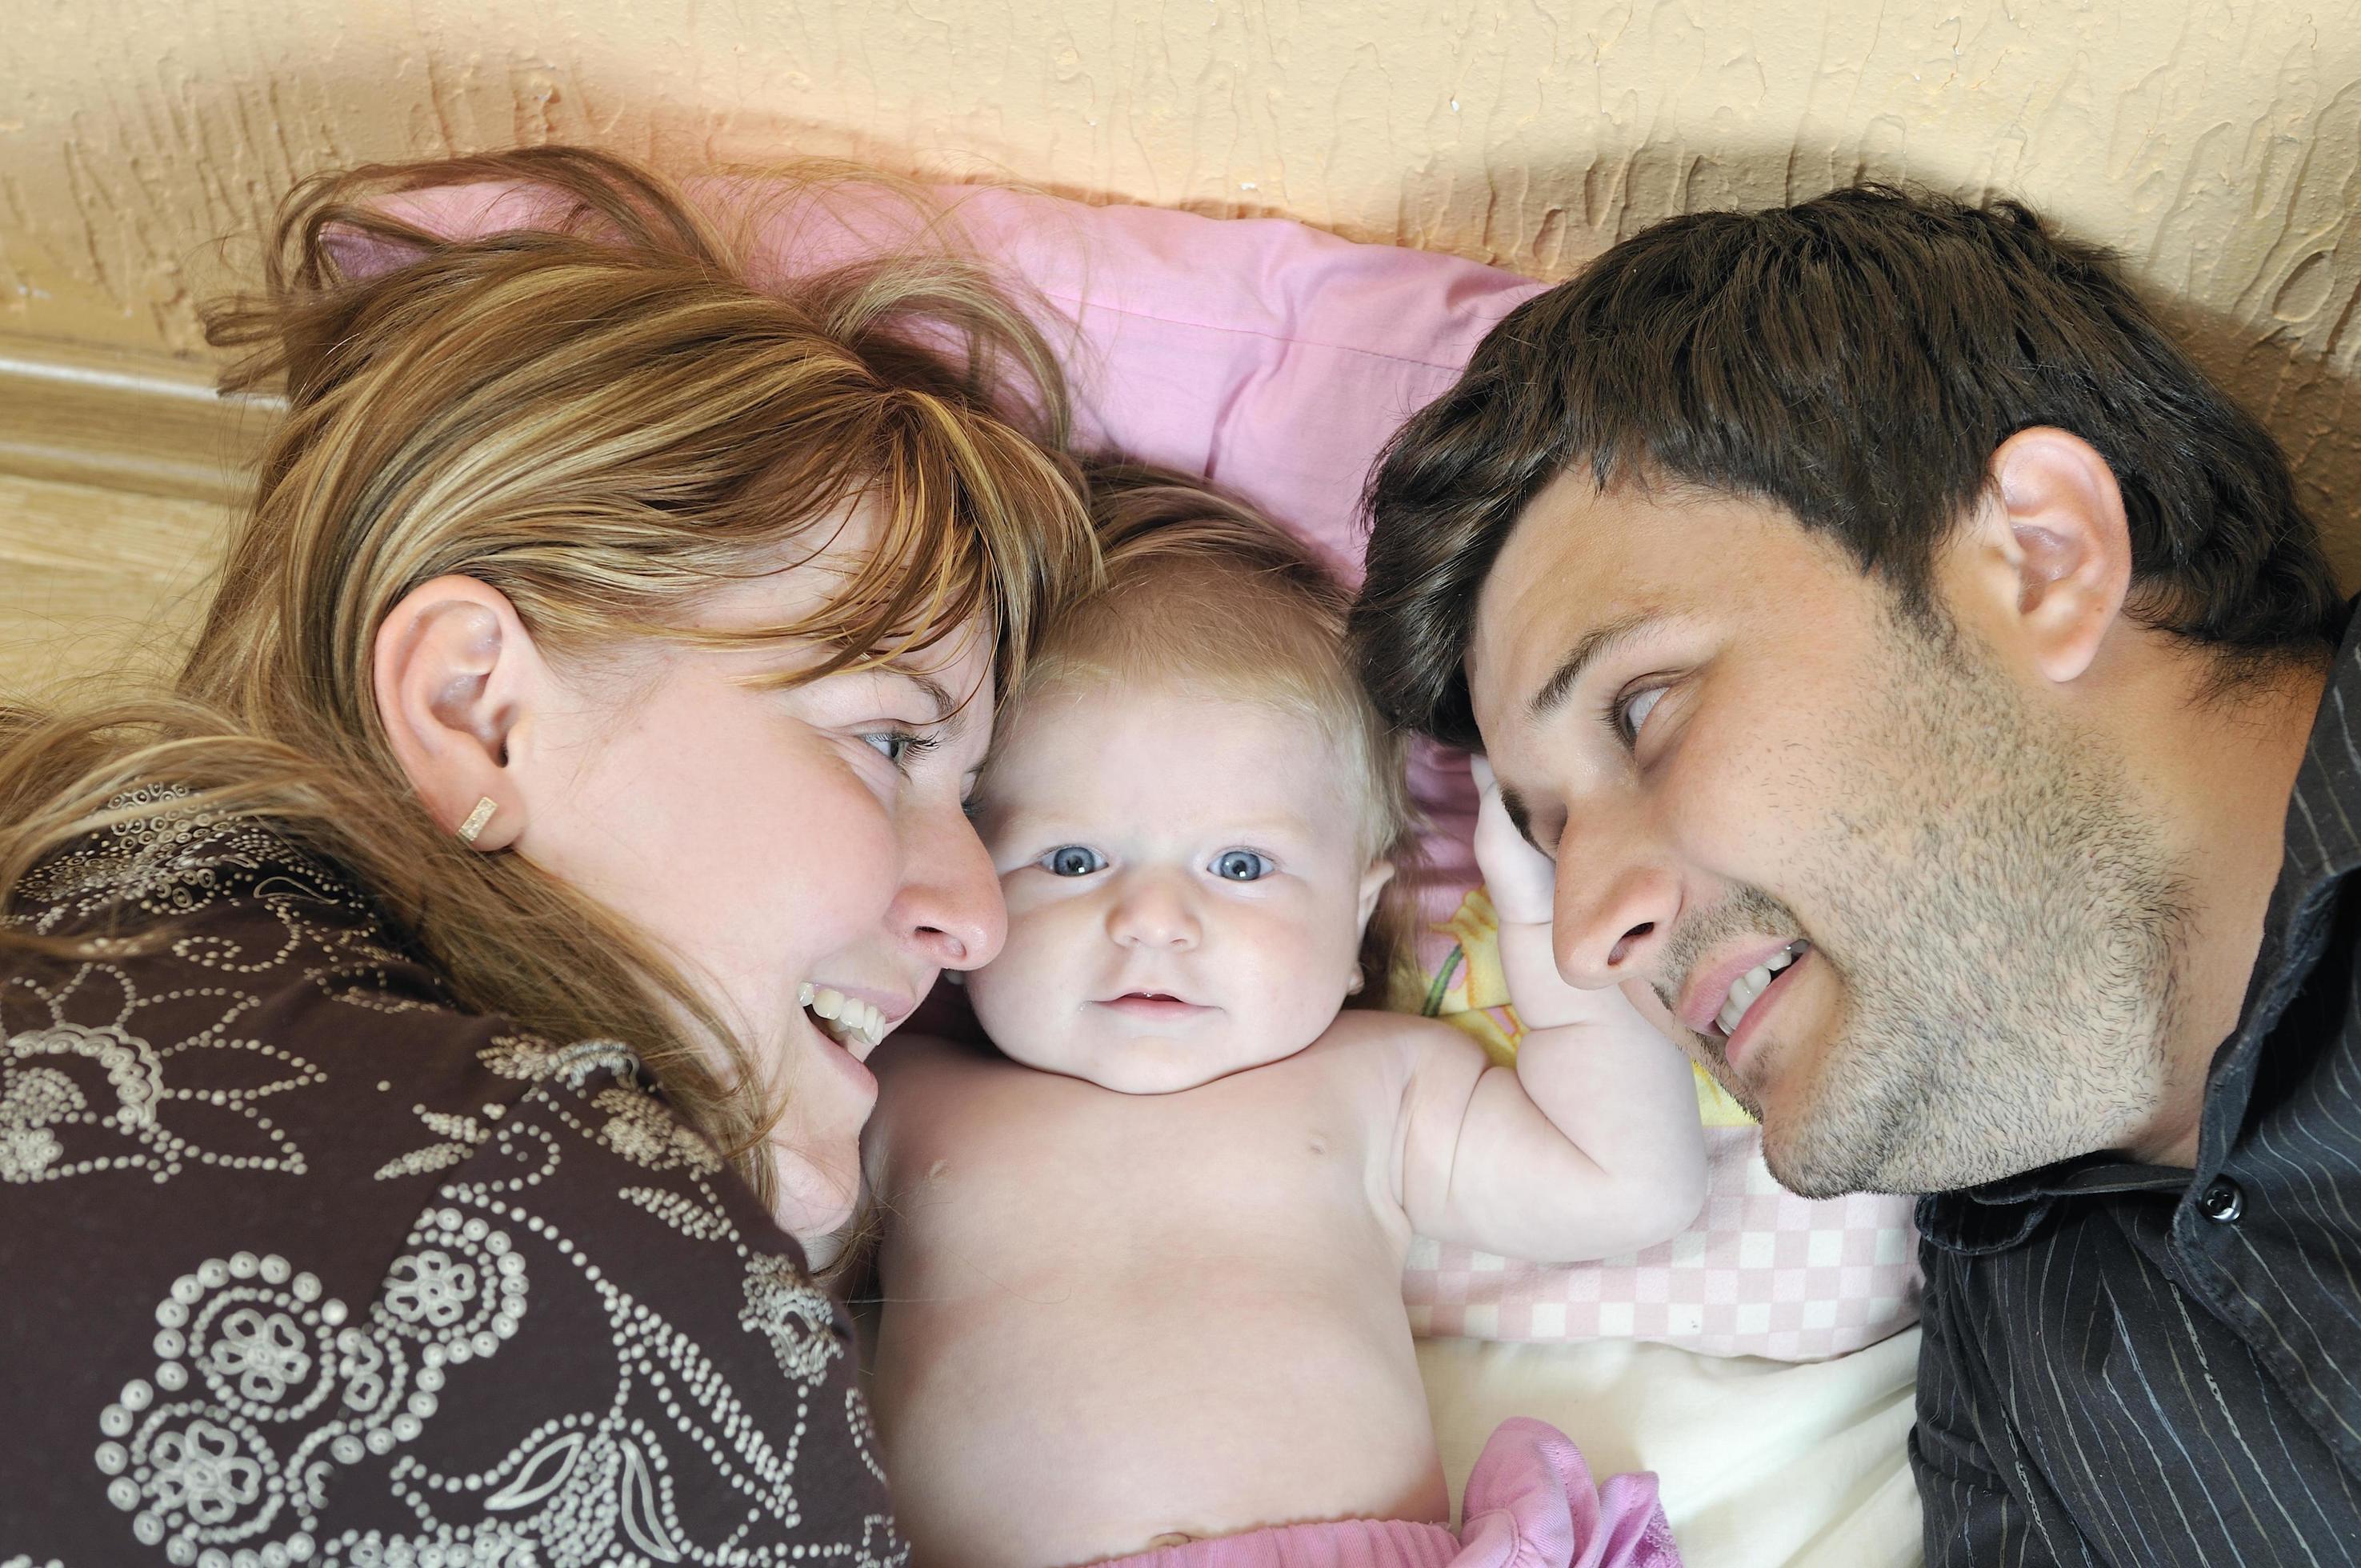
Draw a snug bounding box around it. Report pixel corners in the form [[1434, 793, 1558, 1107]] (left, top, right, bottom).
[[1400, 762, 1705, 1263]]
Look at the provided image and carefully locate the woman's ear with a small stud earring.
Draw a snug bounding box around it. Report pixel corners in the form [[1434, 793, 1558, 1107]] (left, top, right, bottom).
[[370, 576, 543, 850]]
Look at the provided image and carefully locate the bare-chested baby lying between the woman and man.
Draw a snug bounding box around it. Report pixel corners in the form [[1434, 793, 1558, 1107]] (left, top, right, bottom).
[[866, 470, 1705, 1568]]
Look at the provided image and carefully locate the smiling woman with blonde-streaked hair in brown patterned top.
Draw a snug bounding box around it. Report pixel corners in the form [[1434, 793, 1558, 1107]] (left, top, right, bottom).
[[0, 151, 1095, 1566]]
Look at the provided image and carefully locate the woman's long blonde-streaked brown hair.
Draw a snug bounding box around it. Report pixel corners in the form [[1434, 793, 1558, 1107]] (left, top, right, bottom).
[[0, 149, 1095, 1198]]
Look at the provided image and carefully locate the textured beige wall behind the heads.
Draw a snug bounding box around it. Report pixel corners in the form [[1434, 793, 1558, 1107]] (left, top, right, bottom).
[[0, 0, 2361, 559]]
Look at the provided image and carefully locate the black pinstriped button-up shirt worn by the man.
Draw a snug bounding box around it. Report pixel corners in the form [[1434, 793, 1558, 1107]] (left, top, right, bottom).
[[1910, 618, 2361, 1568]]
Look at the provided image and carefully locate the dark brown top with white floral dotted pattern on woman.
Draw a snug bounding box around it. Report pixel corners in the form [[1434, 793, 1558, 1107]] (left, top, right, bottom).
[[0, 791, 906, 1568]]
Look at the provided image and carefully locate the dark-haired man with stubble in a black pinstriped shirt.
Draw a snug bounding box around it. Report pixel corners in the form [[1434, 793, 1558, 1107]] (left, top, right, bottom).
[[1355, 189, 2361, 1568]]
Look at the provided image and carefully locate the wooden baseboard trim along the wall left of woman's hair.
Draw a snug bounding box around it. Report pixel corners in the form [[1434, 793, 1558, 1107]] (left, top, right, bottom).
[[0, 338, 281, 503]]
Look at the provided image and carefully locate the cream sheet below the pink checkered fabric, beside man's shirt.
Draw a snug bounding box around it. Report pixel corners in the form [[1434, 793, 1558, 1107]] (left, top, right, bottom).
[[1419, 1330, 1922, 1568]]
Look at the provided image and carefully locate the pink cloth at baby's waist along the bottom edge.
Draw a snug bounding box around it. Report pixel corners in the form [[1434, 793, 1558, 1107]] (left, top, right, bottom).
[[1105, 1417, 1681, 1568]]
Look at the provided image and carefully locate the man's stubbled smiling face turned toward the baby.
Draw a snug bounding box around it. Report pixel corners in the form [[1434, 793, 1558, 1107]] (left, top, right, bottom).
[[1469, 472, 2175, 1195]]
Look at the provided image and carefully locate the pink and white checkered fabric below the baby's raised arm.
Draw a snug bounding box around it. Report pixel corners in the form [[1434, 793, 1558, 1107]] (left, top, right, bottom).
[[1403, 1126, 1919, 1360]]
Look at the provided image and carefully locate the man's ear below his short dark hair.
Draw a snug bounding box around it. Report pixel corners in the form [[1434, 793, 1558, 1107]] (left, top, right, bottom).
[[1952, 425, 2132, 682]]
